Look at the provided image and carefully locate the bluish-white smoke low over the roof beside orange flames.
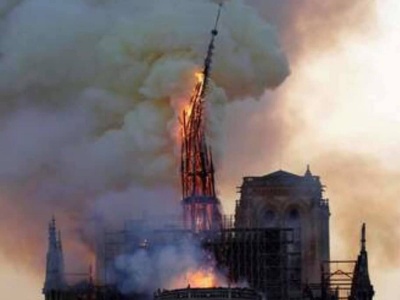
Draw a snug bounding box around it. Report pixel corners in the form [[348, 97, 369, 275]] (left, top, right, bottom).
[[116, 240, 228, 294]]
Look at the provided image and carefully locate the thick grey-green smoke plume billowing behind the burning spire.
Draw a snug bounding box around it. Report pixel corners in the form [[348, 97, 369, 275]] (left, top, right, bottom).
[[0, 0, 288, 276]]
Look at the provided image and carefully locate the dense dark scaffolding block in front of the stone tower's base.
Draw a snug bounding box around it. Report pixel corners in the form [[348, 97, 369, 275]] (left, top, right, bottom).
[[204, 228, 301, 300]]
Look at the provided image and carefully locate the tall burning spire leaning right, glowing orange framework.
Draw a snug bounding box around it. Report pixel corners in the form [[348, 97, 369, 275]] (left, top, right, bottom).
[[181, 4, 222, 233]]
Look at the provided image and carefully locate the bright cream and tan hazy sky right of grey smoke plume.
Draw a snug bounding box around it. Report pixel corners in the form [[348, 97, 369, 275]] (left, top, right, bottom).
[[221, 0, 400, 299]]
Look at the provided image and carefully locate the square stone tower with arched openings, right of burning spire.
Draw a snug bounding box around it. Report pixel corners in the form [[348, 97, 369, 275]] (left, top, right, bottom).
[[235, 167, 330, 284]]
